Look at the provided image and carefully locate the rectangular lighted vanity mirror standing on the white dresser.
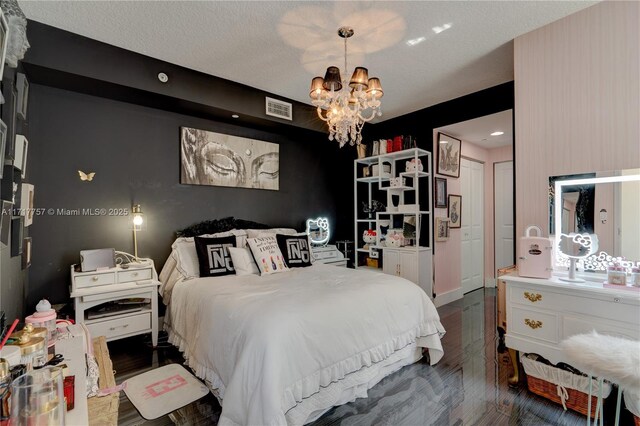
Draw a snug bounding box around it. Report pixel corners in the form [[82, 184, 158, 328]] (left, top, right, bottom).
[[549, 169, 640, 272]]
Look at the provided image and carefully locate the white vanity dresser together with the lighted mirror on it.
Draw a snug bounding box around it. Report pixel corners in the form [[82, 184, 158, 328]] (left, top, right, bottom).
[[500, 169, 640, 384]]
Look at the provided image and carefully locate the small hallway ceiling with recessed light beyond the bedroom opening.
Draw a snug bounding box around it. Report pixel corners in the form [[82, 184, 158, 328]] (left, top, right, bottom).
[[435, 109, 513, 149]]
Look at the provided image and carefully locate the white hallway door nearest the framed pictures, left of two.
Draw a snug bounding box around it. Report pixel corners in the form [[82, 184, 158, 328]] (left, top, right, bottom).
[[460, 158, 484, 293]]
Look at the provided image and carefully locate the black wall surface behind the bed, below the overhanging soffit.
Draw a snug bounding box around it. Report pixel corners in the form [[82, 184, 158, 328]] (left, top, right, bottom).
[[27, 84, 354, 307]]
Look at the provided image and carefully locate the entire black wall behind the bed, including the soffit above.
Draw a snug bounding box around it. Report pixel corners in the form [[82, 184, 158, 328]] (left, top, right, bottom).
[[23, 21, 356, 310]]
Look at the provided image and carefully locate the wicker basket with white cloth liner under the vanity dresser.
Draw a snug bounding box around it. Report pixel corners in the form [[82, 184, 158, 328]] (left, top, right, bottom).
[[521, 354, 612, 420]]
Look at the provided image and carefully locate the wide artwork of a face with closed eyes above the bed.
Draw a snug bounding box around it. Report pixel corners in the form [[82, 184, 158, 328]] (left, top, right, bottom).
[[180, 127, 280, 191]]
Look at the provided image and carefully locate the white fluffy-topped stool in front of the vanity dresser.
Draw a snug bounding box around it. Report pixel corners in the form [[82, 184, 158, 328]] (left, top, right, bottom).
[[560, 331, 640, 426]]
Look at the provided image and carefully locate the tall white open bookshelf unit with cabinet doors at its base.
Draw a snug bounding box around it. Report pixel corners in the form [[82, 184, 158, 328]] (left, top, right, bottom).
[[353, 148, 433, 297]]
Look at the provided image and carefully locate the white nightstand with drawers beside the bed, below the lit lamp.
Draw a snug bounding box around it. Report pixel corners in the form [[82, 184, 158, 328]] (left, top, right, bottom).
[[71, 259, 160, 347]]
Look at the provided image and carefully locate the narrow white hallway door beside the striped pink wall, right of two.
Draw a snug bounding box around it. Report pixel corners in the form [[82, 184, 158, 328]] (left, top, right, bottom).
[[494, 161, 515, 270]]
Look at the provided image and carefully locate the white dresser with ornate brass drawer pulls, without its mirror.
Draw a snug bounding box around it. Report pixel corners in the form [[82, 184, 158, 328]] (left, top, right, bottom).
[[500, 274, 640, 384]]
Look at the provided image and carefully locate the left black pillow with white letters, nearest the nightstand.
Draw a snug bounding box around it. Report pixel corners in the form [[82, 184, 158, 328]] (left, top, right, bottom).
[[193, 235, 236, 277]]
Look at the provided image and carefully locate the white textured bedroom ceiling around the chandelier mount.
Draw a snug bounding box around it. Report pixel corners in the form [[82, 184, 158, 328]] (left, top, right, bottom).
[[19, 0, 595, 120]]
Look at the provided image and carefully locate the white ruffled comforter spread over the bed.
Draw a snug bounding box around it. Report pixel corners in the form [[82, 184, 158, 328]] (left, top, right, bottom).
[[168, 264, 444, 425]]
